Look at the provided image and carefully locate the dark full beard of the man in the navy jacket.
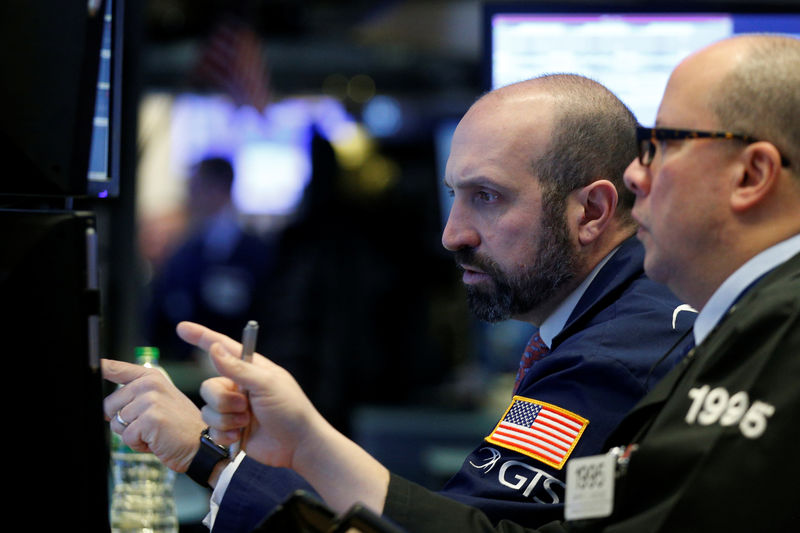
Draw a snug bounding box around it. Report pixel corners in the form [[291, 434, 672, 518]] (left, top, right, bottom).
[[454, 204, 578, 323]]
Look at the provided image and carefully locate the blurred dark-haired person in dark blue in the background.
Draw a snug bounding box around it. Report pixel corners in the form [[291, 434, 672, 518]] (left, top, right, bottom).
[[144, 157, 275, 362]]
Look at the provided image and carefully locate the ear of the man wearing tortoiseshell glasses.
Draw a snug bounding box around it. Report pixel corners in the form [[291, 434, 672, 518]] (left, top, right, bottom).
[[731, 141, 781, 212]]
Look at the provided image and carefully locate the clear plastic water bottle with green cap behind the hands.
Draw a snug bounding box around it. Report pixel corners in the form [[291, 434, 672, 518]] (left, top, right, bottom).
[[110, 346, 178, 533]]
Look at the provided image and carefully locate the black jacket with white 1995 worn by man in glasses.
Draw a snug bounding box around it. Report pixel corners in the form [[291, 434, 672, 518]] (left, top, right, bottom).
[[385, 250, 800, 533]]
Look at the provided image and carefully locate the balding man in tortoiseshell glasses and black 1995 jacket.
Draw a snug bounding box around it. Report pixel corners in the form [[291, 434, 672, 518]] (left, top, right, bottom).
[[181, 35, 800, 533]]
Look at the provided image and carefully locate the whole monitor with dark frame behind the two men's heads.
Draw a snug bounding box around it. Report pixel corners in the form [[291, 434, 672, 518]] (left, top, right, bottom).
[[483, 2, 800, 125]]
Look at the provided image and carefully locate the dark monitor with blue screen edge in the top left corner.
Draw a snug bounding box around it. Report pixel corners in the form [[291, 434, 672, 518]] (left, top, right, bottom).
[[0, 0, 124, 197]]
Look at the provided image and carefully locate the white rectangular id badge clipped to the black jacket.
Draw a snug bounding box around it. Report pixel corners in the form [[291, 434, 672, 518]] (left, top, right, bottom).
[[564, 454, 617, 520]]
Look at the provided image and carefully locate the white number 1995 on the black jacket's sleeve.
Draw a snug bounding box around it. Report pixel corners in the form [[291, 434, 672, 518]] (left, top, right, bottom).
[[686, 385, 775, 439]]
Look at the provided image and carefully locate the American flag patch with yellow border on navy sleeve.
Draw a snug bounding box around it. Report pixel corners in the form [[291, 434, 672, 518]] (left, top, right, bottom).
[[486, 396, 589, 470]]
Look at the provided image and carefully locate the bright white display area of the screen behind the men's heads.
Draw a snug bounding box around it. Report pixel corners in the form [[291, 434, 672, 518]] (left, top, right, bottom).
[[492, 15, 733, 124]]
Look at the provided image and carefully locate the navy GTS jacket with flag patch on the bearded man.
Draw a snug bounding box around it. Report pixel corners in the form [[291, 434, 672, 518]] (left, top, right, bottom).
[[213, 237, 696, 533]]
